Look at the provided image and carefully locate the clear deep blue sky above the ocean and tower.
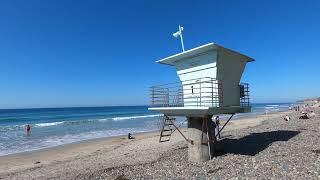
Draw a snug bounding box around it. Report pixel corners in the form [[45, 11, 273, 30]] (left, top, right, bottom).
[[0, 0, 320, 108]]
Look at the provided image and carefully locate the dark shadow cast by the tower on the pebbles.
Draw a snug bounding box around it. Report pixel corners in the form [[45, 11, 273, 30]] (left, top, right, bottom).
[[216, 131, 300, 156]]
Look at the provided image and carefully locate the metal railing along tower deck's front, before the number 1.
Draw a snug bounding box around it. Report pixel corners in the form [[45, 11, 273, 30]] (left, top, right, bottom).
[[150, 77, 223, 107]]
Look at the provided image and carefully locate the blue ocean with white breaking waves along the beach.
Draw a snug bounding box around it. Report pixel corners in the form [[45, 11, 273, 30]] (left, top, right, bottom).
[[0, 103, 293, 156]]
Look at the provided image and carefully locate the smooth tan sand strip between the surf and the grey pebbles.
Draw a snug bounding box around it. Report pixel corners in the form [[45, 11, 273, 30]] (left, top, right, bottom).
[[0, 111, 291, 178]]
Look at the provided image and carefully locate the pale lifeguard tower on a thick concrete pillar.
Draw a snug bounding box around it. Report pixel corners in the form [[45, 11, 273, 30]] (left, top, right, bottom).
[[149, 43, 254, 162]]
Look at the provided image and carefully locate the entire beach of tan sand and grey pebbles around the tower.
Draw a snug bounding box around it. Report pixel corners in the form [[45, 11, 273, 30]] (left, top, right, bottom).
[[0, 108, 320, 179]]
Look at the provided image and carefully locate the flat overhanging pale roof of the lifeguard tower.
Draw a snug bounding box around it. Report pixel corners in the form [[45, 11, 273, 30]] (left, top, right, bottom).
[[156, 42, 254, 66]]
